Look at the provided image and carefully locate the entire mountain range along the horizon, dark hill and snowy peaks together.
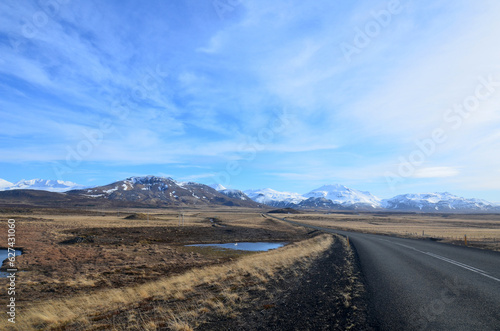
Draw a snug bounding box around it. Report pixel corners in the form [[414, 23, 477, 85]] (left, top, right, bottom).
[[0, 176, 500, 212]]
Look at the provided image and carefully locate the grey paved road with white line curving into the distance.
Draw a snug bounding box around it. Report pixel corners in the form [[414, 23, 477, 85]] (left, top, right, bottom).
[[270, 217, 500, 330]]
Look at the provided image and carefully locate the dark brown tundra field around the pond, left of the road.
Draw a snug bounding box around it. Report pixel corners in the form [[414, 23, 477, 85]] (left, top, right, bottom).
[[0, 208, 309, 307]]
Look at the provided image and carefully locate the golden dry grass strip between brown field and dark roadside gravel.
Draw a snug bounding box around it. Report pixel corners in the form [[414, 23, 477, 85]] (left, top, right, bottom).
[[6, 235, 333, 330]]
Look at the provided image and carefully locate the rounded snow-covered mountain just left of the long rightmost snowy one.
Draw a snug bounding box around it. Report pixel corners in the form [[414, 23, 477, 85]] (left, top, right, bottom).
[[304, 184, 381, 208]]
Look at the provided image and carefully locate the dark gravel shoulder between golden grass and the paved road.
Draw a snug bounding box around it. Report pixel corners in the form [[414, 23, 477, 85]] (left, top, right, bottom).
[[204, 240, 373, 330]]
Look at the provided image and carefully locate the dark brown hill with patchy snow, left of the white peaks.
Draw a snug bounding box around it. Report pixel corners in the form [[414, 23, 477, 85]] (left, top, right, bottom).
[[0, 176, 262, 208]]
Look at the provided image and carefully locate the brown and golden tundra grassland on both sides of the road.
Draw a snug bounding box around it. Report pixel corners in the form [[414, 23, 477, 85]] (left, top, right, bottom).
[[0, 208, 500, 330]]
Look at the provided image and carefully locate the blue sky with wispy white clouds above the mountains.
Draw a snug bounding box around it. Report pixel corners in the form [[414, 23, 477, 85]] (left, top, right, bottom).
[[0, 0, 500, 202]]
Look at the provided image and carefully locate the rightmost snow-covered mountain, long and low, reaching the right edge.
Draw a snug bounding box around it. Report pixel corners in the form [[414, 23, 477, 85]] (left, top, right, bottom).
[[382, 192, 500, 212]]
